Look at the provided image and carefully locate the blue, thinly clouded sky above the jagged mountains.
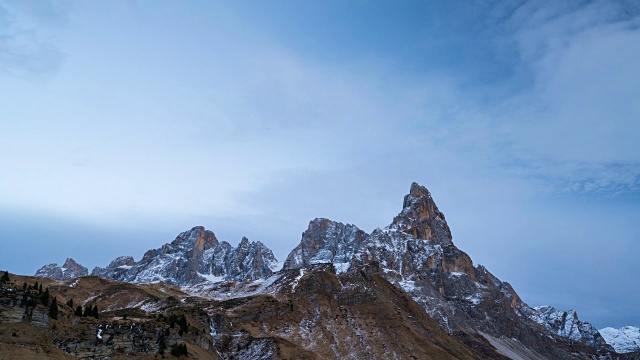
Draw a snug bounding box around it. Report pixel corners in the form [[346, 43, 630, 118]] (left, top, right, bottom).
[[0, 0, 640, 328]]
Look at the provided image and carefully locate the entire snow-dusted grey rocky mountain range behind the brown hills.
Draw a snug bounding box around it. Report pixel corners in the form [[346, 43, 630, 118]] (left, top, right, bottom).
[[31, 183, 637, 359]]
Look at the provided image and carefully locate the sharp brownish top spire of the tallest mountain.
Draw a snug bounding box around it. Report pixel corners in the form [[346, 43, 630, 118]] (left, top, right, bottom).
[[390, 182, 452, 245]]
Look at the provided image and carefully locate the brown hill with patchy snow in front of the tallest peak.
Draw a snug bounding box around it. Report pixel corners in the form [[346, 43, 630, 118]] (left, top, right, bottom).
[[195, 264, 506, 359]]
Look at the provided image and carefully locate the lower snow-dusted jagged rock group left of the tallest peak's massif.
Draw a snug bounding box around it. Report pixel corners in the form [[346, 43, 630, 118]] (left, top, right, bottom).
[[91, 226, 278, 285]]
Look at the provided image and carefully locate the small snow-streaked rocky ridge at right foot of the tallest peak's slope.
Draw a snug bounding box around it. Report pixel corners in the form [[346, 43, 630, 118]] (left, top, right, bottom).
[[525, 306, 608, 349]]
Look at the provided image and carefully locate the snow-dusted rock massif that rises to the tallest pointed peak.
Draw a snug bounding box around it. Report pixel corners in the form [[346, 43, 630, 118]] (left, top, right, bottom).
[[284, 183, 606, 359]]
